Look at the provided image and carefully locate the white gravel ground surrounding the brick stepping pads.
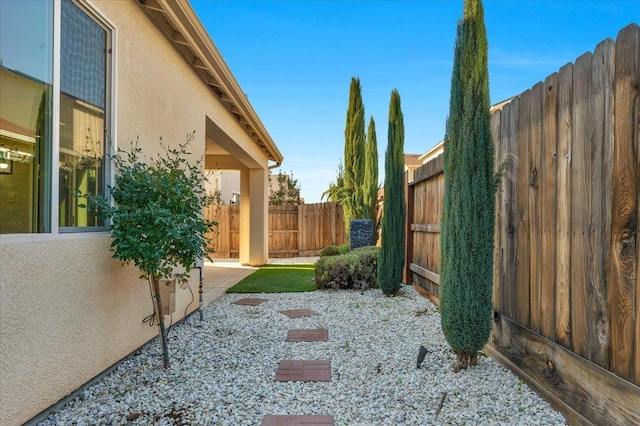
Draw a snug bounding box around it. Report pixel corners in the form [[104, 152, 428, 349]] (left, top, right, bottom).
[[41, 287, 565, 425]]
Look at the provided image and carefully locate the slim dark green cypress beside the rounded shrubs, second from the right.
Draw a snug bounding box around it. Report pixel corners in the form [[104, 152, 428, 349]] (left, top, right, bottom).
[[378, 90, 406, 296]]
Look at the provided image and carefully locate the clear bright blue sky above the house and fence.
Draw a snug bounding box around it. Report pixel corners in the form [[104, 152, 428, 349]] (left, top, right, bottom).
[[191, 0, 640, 202]]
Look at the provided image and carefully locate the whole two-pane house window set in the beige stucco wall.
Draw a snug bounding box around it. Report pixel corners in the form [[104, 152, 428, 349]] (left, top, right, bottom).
[[0, 0, 112, 234]]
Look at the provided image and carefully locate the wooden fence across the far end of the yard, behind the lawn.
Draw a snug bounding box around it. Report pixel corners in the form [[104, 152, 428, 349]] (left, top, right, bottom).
[[205, 203, 346, 258]]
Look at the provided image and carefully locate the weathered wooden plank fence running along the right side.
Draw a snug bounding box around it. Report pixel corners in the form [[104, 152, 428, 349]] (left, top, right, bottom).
[[407, 25, 640, 425]]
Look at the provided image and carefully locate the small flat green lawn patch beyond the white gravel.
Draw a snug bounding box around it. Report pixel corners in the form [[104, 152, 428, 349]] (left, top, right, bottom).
[[227, 263, 316, 293]]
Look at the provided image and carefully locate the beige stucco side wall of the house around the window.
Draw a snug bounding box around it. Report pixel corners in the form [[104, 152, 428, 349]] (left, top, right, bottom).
[[0, 0, 268, 425]]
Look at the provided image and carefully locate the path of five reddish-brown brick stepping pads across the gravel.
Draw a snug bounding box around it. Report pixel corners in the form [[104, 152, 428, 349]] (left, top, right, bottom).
[[233, 297, 334, 426]]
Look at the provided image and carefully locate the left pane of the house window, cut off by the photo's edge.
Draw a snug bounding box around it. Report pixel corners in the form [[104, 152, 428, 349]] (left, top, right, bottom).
[[0, 1, 54, 234]]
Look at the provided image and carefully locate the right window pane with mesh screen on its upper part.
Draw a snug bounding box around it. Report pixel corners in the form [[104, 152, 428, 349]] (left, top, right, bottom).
[[58, 0, 109, 228]]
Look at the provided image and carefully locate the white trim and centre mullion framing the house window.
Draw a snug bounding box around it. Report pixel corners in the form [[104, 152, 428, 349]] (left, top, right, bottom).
[[0, 0, 118, 244]]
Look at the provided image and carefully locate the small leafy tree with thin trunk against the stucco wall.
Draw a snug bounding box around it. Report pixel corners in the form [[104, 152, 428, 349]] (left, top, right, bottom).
[[84, 132, 216, 368]]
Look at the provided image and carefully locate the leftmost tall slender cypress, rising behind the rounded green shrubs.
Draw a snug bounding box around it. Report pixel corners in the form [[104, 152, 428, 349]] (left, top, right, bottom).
[[343, 77, 365, 234]]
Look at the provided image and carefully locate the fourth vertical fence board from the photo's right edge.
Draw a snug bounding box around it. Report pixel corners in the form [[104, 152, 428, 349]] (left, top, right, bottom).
[[555, 64, 573, 349]]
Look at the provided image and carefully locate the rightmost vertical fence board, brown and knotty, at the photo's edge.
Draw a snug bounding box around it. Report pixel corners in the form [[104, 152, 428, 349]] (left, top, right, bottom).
[[609, 22, 640, 381]]
